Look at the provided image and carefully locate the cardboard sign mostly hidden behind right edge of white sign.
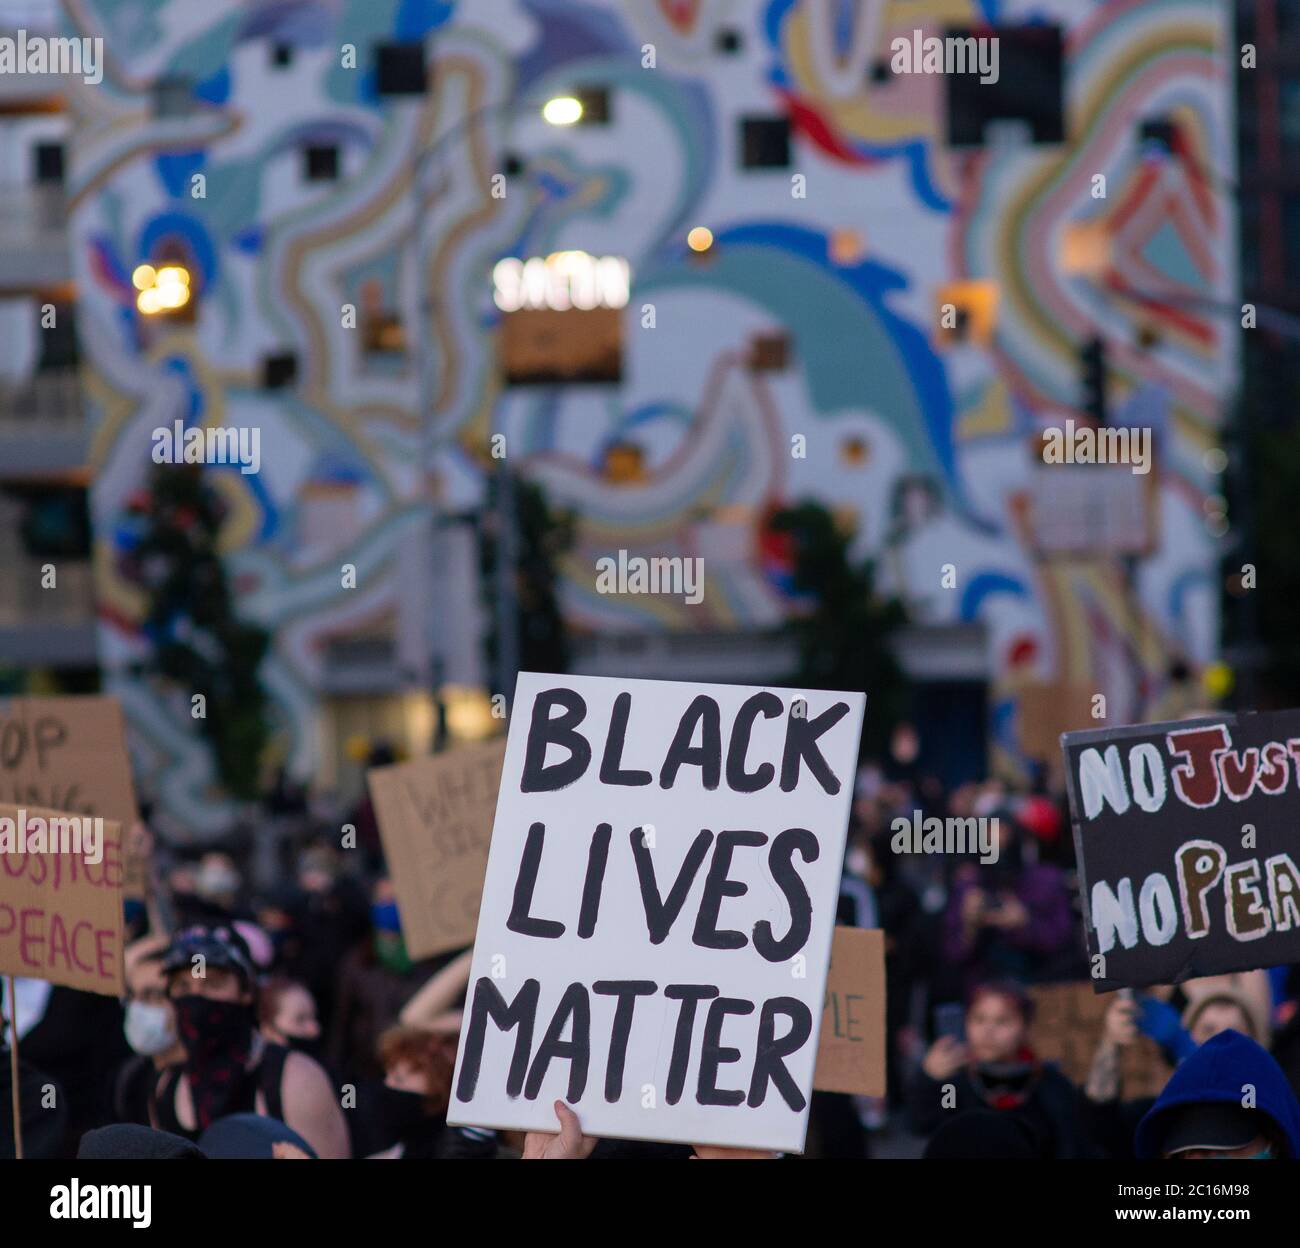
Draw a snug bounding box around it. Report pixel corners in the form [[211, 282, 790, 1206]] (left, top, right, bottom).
[[813, 927, 885, 1096]]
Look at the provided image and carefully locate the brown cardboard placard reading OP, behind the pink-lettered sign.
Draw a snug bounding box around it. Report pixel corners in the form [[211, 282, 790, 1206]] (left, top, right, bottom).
[[0, 696, 148, 897]]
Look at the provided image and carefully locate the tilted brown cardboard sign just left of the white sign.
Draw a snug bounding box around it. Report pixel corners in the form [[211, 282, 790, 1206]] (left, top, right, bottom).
[[367, 741, 506, 958]]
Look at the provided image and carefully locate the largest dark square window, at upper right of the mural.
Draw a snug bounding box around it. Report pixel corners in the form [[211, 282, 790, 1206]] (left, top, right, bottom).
[[944, 26, 1065, 147]]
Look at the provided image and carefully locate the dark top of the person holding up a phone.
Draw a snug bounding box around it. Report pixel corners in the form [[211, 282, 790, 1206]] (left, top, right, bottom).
[[906, 1063, 1099, 1161]]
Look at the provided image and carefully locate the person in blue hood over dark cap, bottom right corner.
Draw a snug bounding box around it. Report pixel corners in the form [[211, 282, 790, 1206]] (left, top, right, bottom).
[[1134, 1031, 1300, 1161]]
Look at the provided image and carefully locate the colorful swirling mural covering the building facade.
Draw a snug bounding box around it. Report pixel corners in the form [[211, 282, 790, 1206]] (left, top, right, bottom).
[[66, 0, 1236, 822]]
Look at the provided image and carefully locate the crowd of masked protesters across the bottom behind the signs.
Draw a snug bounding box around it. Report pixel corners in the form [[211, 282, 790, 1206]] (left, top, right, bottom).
[[0, 738, 1300, 1160]]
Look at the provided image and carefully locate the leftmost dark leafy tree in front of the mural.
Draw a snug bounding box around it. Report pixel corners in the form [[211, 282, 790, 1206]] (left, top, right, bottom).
[[124, 464, 270, 800]]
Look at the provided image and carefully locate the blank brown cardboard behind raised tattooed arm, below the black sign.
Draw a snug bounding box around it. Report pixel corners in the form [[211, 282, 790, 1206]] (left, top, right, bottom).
[[1030, 983, 1171, 1099]]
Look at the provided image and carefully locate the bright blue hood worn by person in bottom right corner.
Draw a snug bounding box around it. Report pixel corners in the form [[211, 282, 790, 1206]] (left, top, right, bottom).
[[1134, 1031, 1300, 1157]]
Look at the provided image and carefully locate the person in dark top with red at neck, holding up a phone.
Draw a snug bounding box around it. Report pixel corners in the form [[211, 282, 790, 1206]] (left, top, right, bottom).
[[907, 982, 1097, 1160]]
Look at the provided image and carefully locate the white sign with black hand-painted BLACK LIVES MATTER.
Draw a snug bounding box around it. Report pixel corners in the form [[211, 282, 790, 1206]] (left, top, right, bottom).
[[447, 672, 866, 1151]]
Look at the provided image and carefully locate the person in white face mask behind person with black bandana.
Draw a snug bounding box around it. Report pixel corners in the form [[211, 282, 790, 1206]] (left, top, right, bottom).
[[112, 936, 185, 1126]]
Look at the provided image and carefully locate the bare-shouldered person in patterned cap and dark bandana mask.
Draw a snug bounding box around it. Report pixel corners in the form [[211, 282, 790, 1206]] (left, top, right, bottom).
[[152, 927, 350, 1157]]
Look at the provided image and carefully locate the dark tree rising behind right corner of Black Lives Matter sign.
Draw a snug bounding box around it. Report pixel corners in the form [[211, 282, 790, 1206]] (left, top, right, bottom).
[[768, 502, 907, 755]]
